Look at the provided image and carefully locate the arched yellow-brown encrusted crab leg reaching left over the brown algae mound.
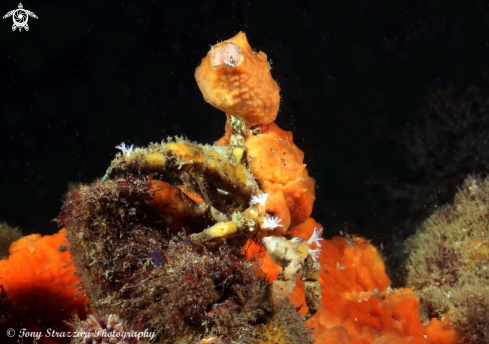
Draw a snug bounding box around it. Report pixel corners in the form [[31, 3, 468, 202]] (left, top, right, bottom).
[[104, 139, 259, 212]]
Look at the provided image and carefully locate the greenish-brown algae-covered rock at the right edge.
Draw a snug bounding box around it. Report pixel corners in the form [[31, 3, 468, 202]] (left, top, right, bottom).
[[406, 177, 489, 344]]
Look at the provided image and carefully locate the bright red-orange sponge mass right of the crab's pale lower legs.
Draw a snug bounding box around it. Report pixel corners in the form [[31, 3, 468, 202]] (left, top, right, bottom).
[[247, 218, 457, 344]]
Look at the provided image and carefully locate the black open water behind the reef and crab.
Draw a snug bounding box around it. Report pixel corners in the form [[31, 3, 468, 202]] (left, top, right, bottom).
[[0, 0, 489, 281]]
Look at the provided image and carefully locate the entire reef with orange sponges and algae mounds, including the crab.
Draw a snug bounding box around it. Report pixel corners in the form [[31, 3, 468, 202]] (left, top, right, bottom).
[[0, 33, 489, 344]]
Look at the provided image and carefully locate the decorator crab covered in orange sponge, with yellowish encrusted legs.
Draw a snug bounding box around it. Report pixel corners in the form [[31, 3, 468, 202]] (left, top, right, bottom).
[[103, 32, 322, 319]]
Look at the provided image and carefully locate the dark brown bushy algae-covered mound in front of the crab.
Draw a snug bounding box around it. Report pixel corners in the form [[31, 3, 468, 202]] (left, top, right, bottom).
[[59, 175, 310, 343]]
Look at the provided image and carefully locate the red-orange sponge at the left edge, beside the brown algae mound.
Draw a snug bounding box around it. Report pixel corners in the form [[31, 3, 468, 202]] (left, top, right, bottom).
[[0, 229, 87, 343]]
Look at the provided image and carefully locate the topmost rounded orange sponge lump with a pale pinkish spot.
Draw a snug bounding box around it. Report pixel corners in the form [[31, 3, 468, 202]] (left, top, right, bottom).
[[195, 32, 280, 126]]
